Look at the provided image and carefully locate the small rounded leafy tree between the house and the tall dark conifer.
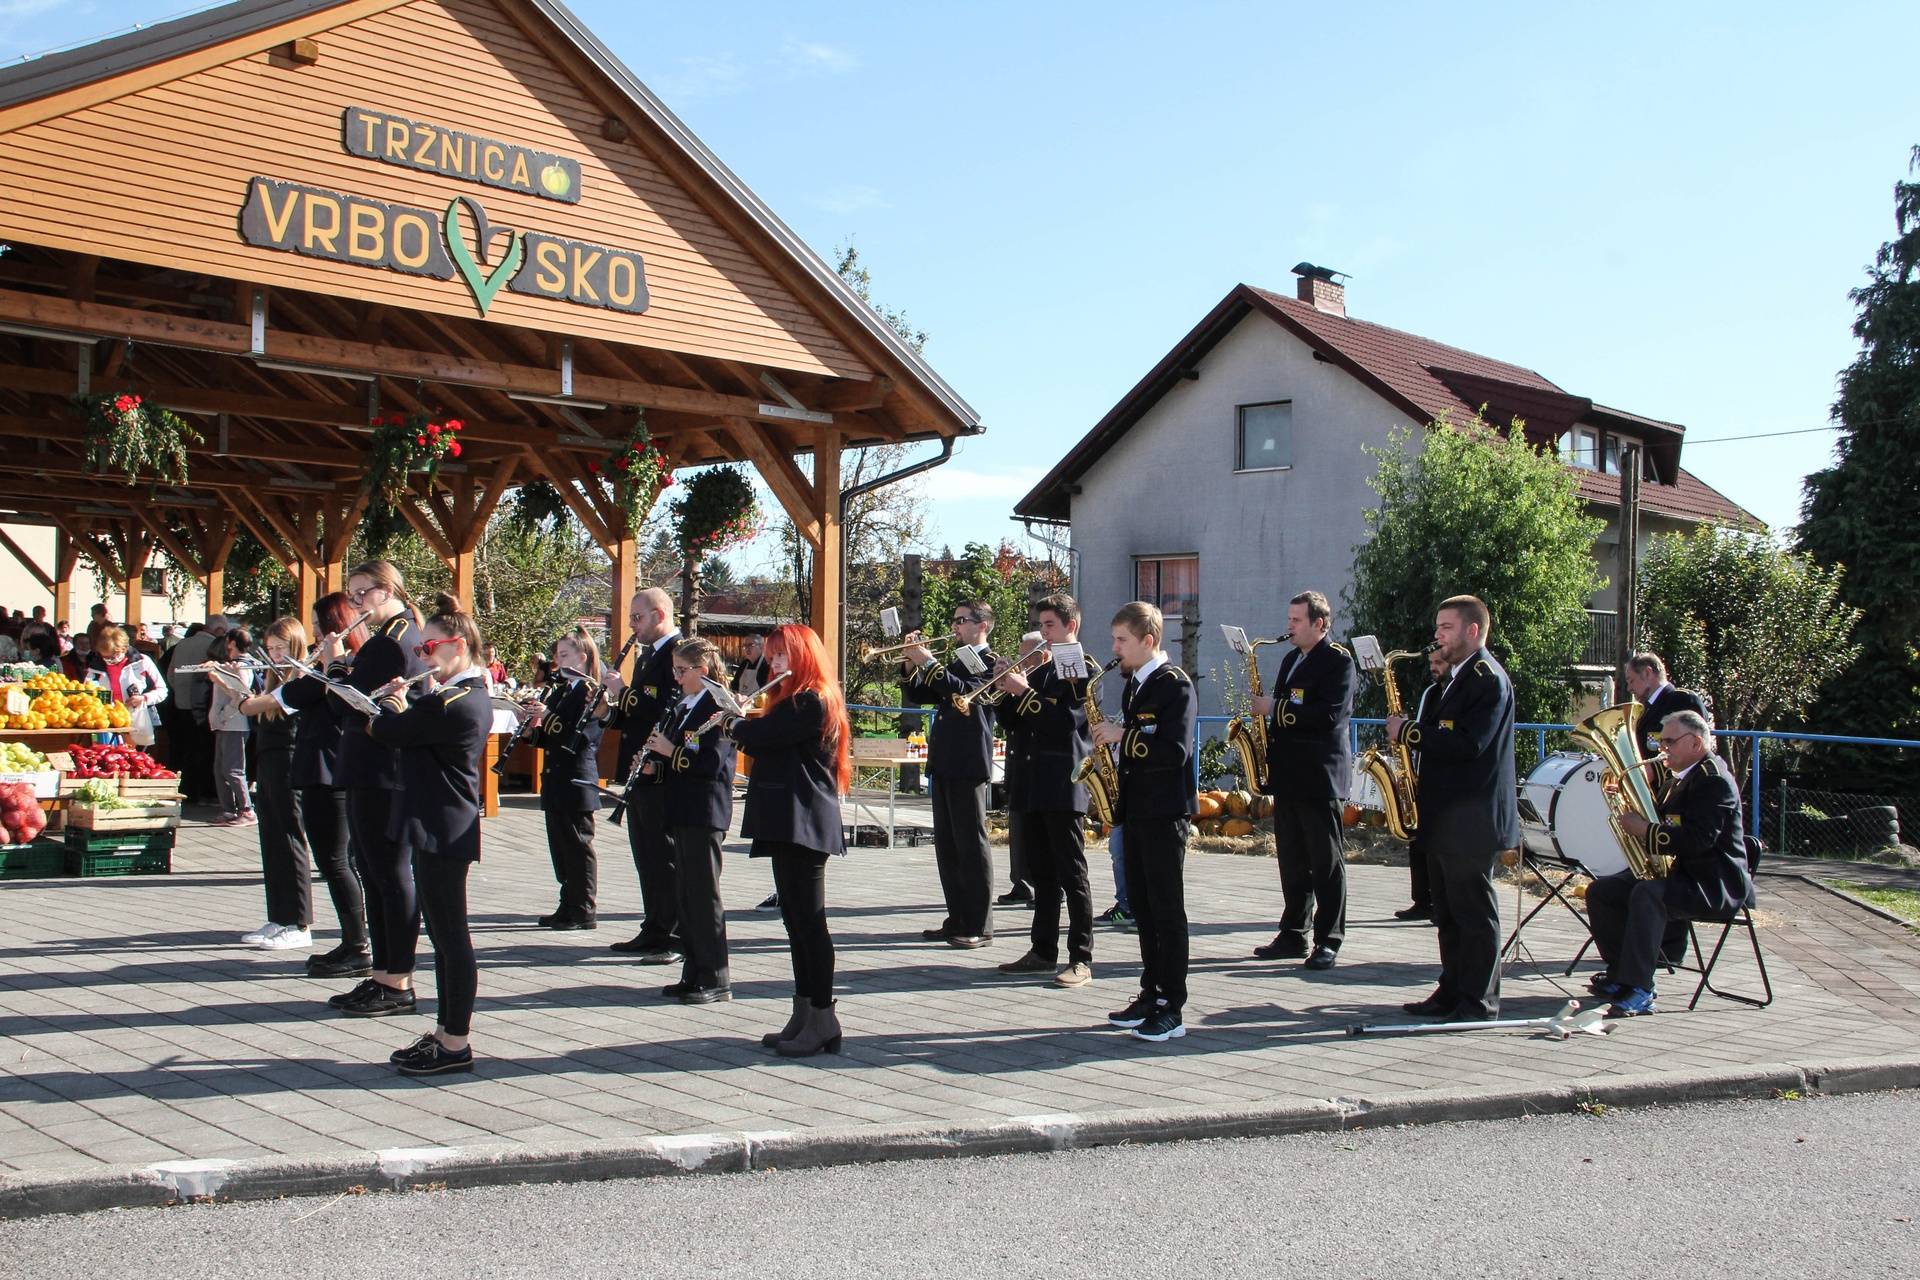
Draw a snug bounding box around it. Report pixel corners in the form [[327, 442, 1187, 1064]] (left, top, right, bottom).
[[1634, 528, 1860, 766]]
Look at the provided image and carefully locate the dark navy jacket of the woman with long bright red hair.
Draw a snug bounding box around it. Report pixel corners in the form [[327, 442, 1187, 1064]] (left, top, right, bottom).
[[733, 689, 847, 858]]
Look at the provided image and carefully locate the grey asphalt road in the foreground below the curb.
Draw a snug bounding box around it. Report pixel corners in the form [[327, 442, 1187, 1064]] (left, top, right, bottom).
[[0, 1092, 1920, 1280]]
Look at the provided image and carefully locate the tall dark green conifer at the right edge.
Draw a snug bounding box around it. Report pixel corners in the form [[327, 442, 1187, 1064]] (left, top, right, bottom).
[[1778, 146, 1920, 793]]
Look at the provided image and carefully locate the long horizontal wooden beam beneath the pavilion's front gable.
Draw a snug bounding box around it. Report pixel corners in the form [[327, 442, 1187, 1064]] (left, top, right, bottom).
[[0, 289, 848, 422]]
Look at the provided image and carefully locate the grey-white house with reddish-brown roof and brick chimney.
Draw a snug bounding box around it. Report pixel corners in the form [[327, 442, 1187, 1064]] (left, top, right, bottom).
[[1014, 263, 1763, 714]]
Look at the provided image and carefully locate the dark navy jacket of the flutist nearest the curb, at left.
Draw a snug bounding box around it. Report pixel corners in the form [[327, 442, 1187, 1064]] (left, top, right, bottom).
[[353, 672, 493, 862]]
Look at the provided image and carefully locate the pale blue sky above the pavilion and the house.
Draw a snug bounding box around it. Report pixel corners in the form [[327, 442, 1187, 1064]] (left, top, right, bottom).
[[0, 0, 1920, 575]]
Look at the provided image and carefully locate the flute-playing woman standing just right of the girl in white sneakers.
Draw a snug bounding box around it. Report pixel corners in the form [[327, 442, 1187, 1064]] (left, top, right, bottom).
[[269, 591, 372, 979]]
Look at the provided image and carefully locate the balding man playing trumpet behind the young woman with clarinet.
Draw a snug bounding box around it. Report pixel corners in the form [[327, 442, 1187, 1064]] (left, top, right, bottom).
[[607, 587, 680, 965]]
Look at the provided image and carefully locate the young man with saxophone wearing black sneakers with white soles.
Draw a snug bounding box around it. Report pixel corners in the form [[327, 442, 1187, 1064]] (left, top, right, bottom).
[[1092, 601, 1200, 1042]]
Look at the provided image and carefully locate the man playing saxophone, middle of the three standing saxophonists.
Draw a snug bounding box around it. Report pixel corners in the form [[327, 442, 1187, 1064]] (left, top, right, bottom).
[[1254, 591, 1354, 969]]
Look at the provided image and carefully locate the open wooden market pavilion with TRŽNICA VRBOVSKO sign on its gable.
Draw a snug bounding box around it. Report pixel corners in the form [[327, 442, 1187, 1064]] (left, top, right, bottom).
[[0, 0, 981, 652]]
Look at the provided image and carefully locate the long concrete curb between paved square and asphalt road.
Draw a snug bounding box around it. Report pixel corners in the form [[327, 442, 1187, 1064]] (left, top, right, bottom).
[[0, 1059, 1920, 1219]]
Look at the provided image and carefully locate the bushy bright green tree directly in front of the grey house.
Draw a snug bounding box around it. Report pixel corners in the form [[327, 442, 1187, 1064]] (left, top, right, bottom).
[[1346, 418, 1607, 722]]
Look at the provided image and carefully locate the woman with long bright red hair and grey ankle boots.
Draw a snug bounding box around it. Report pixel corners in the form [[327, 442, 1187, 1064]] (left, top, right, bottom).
[[732, 624, 852, 1057]]
